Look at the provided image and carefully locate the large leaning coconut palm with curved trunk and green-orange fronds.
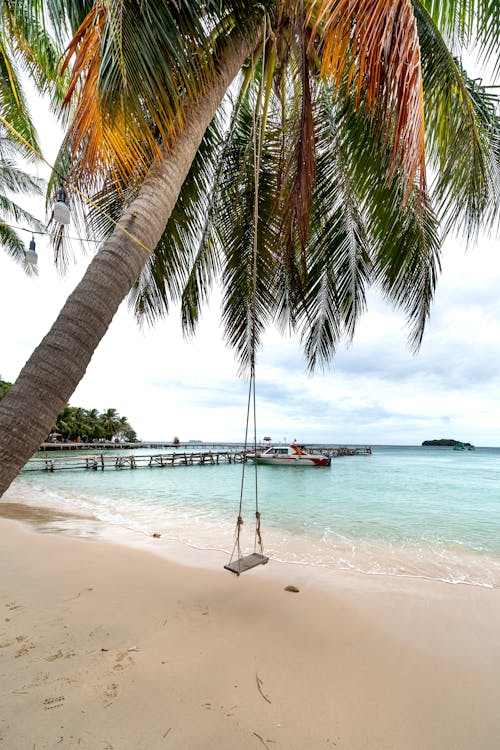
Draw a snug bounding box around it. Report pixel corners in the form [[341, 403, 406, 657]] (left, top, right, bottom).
[[0, 0, 499, 500]]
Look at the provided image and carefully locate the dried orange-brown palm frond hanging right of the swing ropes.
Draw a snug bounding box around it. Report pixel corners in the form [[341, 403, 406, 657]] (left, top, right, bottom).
[[309, 0, 425, 194]]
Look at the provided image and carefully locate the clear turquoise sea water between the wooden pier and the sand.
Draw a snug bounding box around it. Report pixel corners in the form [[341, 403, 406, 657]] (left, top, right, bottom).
[[9, 446, 500, 587]]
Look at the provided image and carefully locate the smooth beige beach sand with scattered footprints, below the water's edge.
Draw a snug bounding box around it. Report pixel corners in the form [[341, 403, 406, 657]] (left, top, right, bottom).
[[0, 502, 500, 750]]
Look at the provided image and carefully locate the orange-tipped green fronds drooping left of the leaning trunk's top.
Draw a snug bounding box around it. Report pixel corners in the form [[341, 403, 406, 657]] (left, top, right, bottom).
[[59, 0, 268, 192]]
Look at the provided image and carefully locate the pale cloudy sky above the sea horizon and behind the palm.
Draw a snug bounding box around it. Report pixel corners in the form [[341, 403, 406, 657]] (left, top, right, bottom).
[[0, 86, 500, 446]]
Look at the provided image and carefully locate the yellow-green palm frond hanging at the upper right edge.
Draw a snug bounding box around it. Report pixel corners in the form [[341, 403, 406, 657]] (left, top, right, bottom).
[[415, 0, 500, 237]]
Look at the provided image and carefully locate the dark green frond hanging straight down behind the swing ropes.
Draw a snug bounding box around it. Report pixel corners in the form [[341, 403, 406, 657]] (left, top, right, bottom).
[[201, 78, 279, 372]]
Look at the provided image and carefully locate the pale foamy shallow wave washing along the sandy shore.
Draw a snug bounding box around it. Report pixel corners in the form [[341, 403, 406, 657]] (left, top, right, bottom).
[[5, 477, 500, 588]]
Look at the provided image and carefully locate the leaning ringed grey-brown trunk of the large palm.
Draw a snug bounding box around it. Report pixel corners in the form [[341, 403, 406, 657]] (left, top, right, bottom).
[[0, 32, 258, 497]]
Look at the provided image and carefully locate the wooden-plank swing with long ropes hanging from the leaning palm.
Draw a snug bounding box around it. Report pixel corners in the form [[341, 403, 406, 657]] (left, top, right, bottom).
[[224, 15, 269, 576]]
